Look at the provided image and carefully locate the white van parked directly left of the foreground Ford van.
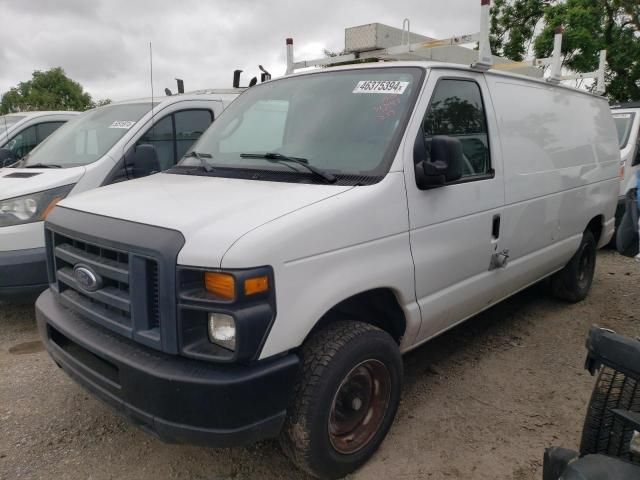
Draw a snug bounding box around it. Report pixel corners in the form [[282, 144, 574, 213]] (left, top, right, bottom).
[[0, 89, 241, 301]]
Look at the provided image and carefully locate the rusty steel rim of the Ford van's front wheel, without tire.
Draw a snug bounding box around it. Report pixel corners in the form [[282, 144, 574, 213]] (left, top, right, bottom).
[[329, 360, 391, 454]]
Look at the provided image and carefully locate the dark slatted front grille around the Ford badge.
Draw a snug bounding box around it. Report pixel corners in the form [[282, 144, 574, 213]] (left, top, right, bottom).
[[51, 232, 161, 348]]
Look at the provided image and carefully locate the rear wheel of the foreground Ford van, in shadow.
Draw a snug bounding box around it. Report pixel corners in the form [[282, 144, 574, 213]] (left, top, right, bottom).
[[551, 230, 597, 302]]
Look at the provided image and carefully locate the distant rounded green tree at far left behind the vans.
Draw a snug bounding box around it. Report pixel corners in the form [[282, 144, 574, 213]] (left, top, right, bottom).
[[0, 67, 111, 114]]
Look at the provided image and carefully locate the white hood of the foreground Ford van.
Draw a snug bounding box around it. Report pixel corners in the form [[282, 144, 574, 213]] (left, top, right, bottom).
[[59, 173, 354, 267]]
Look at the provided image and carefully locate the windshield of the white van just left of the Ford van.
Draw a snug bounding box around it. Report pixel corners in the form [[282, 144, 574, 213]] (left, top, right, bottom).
[[20, 103, 151, 168]]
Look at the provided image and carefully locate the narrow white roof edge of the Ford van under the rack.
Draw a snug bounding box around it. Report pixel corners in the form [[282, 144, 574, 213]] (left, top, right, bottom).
[[282, 60, 605, 100]]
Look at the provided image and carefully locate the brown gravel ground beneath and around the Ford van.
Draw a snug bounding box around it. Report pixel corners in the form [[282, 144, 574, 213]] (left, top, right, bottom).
[[0, 251, 640, 480]]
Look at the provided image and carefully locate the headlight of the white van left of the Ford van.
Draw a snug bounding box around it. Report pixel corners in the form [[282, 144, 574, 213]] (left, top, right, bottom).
[[0, 185, 73, 227]]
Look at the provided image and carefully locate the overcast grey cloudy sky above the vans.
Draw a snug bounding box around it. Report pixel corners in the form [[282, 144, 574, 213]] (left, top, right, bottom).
[[0, 0, 480, 100]]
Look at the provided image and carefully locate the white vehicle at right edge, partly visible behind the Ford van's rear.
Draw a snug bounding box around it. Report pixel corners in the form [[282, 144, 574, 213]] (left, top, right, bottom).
[[611, 102, 640, 226]]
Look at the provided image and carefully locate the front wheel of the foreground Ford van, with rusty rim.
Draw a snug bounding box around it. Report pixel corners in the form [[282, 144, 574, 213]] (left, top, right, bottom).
[[280, 321, 402, 479]]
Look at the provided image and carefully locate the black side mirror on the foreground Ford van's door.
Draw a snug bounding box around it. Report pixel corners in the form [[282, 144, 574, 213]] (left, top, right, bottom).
[[413, 134, 464, 190]]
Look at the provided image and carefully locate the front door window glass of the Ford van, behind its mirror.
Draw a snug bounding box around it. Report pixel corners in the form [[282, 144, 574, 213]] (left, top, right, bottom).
[[423, 80, 491, 177]]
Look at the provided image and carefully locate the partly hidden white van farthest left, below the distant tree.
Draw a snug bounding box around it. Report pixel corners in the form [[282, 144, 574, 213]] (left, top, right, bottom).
[[0, 112, 79, 168]]
